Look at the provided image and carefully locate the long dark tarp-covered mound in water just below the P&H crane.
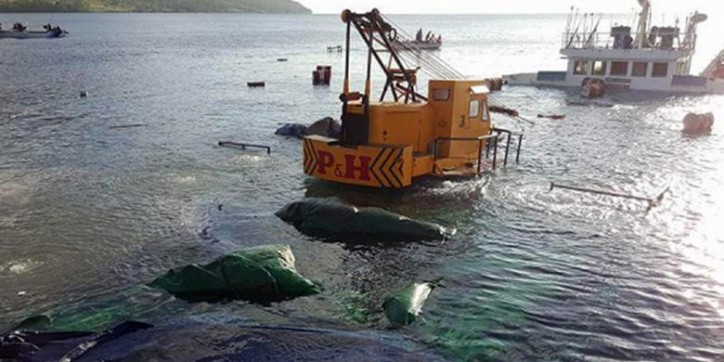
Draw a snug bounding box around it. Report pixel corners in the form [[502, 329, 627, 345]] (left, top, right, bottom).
[[275, 198, 455, 241]]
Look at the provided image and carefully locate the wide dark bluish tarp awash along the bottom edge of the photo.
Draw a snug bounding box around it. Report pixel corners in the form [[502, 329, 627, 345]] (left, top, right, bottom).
[[0, 314, 443, 362]]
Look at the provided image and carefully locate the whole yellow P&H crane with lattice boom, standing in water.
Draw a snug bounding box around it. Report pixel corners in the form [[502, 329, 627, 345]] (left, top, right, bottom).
[[303, 9, 522, 188]]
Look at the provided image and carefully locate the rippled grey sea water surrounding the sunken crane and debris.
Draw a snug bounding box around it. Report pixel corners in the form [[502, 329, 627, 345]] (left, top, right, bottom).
[[0, 14, 724, 361]]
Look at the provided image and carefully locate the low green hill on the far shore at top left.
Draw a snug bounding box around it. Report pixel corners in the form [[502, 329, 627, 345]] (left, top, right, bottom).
[[0, 0, 311, 14]]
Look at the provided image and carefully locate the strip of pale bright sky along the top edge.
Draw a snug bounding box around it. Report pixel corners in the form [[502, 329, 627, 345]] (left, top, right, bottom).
[[296, 0, 724, 15]]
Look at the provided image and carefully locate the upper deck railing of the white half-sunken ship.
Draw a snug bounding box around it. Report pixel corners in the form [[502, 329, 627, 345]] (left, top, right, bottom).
[[561, 31, 695, 50]]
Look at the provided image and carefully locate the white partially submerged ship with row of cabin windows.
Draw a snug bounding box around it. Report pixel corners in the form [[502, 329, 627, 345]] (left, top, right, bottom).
[[503, 0, 724, 94]]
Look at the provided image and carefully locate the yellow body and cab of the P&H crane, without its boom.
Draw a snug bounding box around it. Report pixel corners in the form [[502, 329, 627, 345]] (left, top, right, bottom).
[[304, 80, 491, 188]]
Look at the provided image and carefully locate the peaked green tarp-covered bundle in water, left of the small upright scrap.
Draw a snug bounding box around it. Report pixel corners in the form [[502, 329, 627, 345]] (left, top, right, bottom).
[[150, 245, 319, 302]]
